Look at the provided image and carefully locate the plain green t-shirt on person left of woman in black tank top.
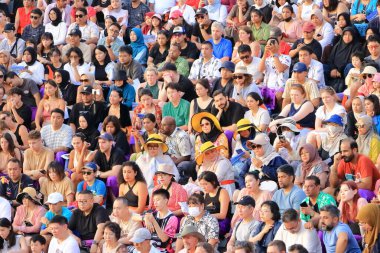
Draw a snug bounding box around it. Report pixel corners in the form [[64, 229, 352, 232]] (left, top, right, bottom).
[[162, 98, 190, 127]]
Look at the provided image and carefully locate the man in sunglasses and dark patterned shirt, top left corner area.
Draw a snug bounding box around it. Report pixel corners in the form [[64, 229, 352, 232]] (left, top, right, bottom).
[[21, 8, 45, 43]]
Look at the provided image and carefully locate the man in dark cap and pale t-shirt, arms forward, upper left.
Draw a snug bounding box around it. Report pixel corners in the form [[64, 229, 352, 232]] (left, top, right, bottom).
[[62, 27, 92, 63]]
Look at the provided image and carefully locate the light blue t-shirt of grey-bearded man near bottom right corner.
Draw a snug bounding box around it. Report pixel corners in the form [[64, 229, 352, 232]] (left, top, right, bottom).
[[323, 222, 362, 253]]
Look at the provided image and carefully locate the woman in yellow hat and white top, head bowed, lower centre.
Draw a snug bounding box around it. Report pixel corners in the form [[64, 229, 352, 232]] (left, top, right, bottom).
[[195, 141, 235, 198]]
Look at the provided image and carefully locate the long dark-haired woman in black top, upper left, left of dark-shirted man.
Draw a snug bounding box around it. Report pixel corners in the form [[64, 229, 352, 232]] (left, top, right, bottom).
[[92, 45, 114, 86]]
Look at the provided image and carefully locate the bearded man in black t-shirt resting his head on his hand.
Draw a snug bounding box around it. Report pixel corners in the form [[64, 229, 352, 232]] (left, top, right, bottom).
[[211, 90, 245, 132]]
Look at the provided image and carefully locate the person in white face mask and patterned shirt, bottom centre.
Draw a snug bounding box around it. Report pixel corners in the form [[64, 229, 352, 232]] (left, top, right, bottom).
[[176, 193, 219, 250]]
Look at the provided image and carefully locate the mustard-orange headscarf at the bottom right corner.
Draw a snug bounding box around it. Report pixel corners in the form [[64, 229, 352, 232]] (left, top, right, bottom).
[[356, 203, 380, 253]]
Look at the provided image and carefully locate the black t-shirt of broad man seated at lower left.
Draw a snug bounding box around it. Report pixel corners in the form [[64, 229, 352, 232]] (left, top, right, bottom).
[[69, 203, 109, 240]]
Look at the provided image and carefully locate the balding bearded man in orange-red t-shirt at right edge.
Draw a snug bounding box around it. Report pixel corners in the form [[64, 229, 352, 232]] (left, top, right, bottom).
[[330, 138, 380, 191]]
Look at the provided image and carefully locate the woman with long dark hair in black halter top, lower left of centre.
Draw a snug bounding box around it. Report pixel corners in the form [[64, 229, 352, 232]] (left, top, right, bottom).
[[118, 162, 149, 214]]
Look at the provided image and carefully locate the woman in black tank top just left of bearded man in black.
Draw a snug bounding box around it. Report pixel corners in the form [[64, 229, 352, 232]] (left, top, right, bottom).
[[188, 79, 214, 133]]
